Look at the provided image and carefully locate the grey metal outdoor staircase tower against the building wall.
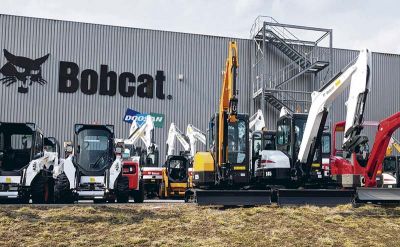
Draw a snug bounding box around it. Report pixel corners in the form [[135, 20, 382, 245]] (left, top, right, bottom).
[[250, 16, 332, 111]]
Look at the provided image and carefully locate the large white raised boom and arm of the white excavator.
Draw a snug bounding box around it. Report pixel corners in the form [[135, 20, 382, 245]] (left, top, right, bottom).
[[297, 49, 371, 178]]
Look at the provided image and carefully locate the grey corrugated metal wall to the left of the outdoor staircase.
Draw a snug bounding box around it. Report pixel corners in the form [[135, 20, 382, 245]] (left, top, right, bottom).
[[0, 15, 251, 160]]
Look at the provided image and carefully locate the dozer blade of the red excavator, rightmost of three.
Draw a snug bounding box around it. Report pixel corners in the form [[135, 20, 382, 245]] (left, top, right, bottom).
[[355, 187, 400, 204]]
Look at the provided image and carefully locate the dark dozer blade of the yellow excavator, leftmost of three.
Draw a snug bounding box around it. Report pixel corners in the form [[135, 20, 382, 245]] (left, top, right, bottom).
[[194, 190, 272, 206]]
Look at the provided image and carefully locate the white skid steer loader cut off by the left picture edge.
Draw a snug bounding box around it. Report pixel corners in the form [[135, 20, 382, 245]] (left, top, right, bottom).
[[0, 122, 58, 203]]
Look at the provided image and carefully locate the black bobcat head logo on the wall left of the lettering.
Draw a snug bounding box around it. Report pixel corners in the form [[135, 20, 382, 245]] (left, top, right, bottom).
[[0, 49, 50, 93]]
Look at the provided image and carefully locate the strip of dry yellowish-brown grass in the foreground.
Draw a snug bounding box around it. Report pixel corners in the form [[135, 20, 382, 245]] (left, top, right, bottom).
[[0, 203, 400, 246]]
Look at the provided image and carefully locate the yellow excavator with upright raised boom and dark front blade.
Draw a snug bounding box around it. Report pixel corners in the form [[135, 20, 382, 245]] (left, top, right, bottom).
[[185, 41, 271, 206]]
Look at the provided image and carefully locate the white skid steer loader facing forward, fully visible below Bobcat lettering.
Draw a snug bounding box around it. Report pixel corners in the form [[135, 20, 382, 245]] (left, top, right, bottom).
[[53, 124, 129, 203]]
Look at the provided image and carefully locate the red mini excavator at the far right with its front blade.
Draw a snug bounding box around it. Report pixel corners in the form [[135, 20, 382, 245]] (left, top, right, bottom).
[[331, 112, 400, 204]]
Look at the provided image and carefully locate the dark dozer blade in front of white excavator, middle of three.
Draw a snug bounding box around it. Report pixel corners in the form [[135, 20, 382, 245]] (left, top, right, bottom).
[[277, 189, 354, 206]]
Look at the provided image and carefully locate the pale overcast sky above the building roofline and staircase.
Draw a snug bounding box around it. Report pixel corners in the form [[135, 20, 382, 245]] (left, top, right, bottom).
[[0, 0, 400, 54]]
